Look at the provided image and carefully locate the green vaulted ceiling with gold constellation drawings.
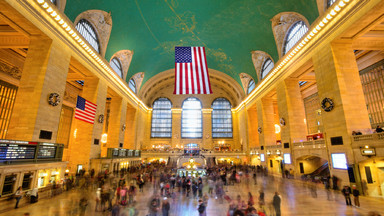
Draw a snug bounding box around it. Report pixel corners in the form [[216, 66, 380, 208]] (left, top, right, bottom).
[[65, 0, 318, 88]]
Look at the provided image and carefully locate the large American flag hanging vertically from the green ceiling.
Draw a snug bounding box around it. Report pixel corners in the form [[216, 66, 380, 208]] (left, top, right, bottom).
[[173, 47, 212, 94]]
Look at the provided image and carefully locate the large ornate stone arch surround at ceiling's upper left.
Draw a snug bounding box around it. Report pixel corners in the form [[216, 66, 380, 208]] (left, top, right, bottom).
[[74, 10, 112, 57]]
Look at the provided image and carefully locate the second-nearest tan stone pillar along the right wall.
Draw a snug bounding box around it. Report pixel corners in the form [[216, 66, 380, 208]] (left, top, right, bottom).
[[276, 79, 308, 146]]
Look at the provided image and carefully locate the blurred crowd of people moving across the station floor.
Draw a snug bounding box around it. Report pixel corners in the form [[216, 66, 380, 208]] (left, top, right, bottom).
[[10, 163, 378, 216]]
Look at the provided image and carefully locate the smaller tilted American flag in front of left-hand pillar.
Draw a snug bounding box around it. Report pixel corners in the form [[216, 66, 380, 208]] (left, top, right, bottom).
[[75, 96, 97, 124]]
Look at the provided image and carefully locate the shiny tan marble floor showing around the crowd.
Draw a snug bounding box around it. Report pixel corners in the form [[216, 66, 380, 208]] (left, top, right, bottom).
[[0, 177, 384, 216]]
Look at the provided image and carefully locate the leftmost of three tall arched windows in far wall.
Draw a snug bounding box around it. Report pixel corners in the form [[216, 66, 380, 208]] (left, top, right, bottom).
[[151, 98, 172, 138]]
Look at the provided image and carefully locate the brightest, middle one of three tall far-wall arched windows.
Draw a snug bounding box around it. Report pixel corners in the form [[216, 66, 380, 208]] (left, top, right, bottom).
[[181, 98, 203, 138]]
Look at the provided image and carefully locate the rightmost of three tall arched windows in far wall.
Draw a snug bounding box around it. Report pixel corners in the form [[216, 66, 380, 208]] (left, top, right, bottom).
[[212, 98, 232, 138]]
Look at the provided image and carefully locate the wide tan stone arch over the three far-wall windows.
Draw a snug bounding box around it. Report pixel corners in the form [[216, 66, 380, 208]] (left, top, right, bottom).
[[138, 69, 245, 109]]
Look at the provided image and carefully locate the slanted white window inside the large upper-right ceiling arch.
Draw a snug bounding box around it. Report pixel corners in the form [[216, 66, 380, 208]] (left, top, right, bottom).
[[283, 21, 308, 55]]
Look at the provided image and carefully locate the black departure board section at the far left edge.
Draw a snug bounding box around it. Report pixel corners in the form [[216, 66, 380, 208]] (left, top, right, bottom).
[[0, 144, 36, 160]]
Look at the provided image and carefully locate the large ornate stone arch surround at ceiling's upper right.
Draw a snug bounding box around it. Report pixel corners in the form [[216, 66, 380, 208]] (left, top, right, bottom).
[[271, 12, 310, 58]]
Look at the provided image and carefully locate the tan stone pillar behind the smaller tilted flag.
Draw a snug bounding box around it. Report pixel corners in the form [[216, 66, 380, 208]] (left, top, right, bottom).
[[64, 77, 107, 173]]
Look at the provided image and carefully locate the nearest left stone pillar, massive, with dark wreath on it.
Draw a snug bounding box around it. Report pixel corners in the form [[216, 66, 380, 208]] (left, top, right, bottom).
[[6, 36, 71, 142]]
